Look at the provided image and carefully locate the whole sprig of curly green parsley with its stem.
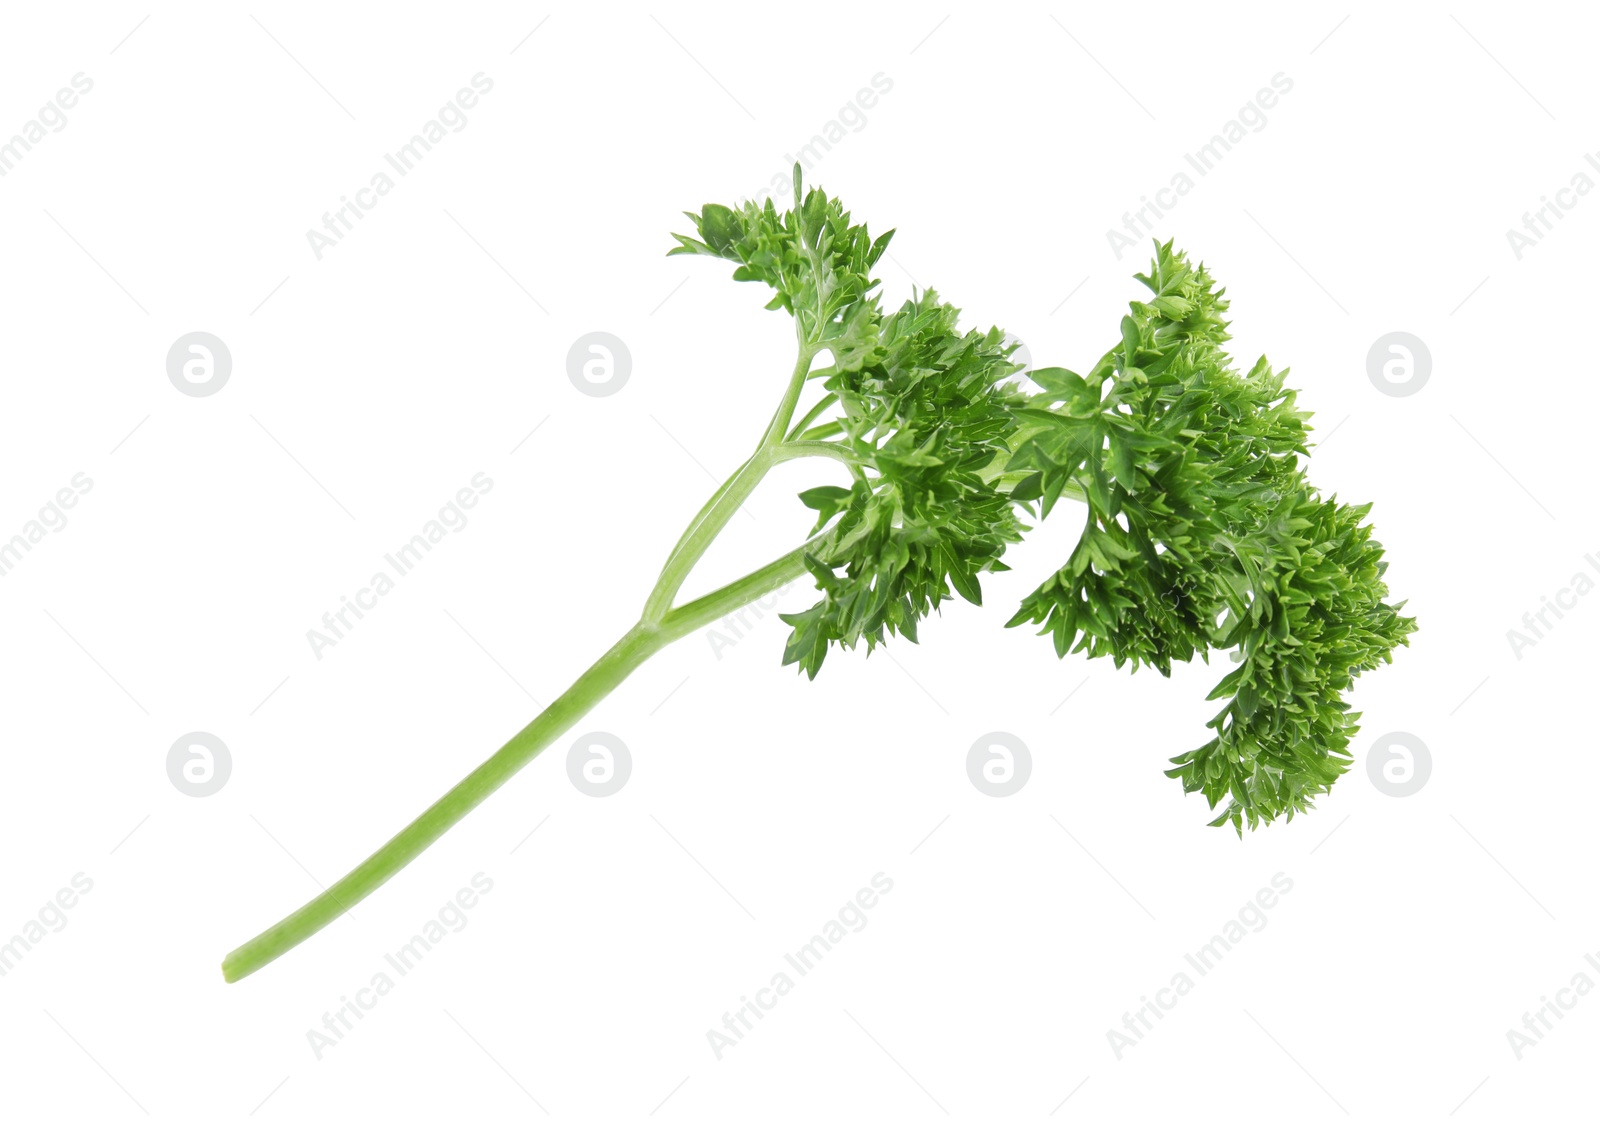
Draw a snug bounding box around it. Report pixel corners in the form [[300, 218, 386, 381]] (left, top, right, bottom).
[[222, 165, 1414, 981]]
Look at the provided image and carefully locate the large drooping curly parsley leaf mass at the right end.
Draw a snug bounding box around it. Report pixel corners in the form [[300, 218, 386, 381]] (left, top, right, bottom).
[[1006, 243, 1416, 834]]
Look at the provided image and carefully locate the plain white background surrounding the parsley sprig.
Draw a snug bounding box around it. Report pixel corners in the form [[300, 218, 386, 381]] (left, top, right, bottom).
[[0, 3, 1600, 1127]]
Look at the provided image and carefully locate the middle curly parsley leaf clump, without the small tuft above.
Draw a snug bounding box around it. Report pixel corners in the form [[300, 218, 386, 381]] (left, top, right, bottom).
[[782, 290, 1022, 679]]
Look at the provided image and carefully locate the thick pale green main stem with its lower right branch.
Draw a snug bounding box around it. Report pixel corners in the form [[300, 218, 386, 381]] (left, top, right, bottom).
[[222, 539, 816, 981]]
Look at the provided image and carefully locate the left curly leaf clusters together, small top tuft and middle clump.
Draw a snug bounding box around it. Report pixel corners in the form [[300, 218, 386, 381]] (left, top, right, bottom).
[[669, 165, 1022, 679]]
